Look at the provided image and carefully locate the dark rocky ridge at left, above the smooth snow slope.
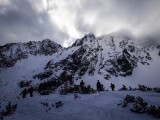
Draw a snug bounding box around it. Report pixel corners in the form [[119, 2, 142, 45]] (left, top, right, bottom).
[[0, 39, 62, 68]]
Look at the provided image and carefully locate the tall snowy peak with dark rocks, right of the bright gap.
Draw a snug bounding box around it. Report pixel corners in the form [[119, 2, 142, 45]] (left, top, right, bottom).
[[34, 33, 159, 87]]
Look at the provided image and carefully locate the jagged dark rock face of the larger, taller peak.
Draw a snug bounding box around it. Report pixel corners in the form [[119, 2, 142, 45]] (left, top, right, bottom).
[[42, 34, 152, 79]]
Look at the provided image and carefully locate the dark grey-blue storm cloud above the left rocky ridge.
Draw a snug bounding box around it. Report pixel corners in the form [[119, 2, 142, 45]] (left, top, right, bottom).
[[0, 0, 68, 45]]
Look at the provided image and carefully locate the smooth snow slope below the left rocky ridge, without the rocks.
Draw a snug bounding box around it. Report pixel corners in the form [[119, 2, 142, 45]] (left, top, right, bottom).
[[0, 55, 56, 101]]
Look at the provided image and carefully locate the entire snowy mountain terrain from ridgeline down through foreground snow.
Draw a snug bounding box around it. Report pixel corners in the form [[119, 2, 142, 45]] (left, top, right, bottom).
[[0, 33, 160, 120]]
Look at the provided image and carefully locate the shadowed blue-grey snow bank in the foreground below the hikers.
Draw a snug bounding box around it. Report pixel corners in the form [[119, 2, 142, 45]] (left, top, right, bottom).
[[5, 91, 160, 120]]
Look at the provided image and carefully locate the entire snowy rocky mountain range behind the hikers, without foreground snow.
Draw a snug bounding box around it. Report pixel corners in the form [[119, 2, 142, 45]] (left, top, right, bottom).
[[0, 32, 160, 88]]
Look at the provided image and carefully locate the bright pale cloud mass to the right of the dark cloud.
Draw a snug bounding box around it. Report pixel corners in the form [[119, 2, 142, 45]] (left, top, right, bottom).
[[47, 0, 160, 46]]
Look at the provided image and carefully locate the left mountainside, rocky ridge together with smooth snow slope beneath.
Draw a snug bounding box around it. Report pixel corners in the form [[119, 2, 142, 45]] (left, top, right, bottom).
[[0, 39, 63, 102]]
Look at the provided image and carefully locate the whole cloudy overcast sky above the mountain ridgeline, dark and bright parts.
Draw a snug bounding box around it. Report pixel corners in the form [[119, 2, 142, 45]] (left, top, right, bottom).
[[0, 0, 160, 46]]
